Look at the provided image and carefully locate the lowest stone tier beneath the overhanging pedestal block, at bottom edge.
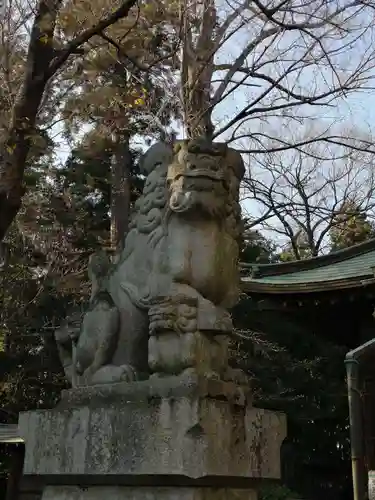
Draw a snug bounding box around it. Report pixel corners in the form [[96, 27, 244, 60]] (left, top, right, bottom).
[[42, 486, 257, 500]]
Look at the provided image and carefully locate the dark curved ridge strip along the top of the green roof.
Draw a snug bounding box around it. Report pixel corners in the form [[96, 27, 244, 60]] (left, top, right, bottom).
[[241, 238, 375, 278]]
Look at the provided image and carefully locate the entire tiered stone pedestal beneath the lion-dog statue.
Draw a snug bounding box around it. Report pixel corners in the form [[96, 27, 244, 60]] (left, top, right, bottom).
[[19, 376, 286, 500]]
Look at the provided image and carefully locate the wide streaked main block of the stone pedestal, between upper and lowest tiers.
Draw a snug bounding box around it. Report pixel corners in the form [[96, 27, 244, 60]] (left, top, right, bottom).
[[19, 398, 285, 478]]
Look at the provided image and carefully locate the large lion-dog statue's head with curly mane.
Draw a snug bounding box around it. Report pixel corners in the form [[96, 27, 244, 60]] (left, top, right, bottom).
[[124, 139, 244, 250]]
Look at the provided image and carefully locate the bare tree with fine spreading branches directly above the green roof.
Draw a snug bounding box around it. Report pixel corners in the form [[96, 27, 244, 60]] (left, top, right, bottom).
[[245, 134, 375, 259]]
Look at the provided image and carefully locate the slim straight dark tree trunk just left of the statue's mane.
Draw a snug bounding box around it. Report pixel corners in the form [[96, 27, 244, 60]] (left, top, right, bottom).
[[111, 136, 132, 260]]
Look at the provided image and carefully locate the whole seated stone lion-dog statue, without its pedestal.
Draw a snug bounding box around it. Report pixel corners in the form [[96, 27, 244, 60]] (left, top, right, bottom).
[[56, 140, 244, 386]]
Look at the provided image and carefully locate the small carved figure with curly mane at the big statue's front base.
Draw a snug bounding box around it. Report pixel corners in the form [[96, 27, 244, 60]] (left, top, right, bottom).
[[149, 285, 232, 379]]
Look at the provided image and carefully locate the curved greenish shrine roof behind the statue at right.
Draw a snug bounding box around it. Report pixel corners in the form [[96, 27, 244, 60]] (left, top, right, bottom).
[[241, 239, 375, 293]]
